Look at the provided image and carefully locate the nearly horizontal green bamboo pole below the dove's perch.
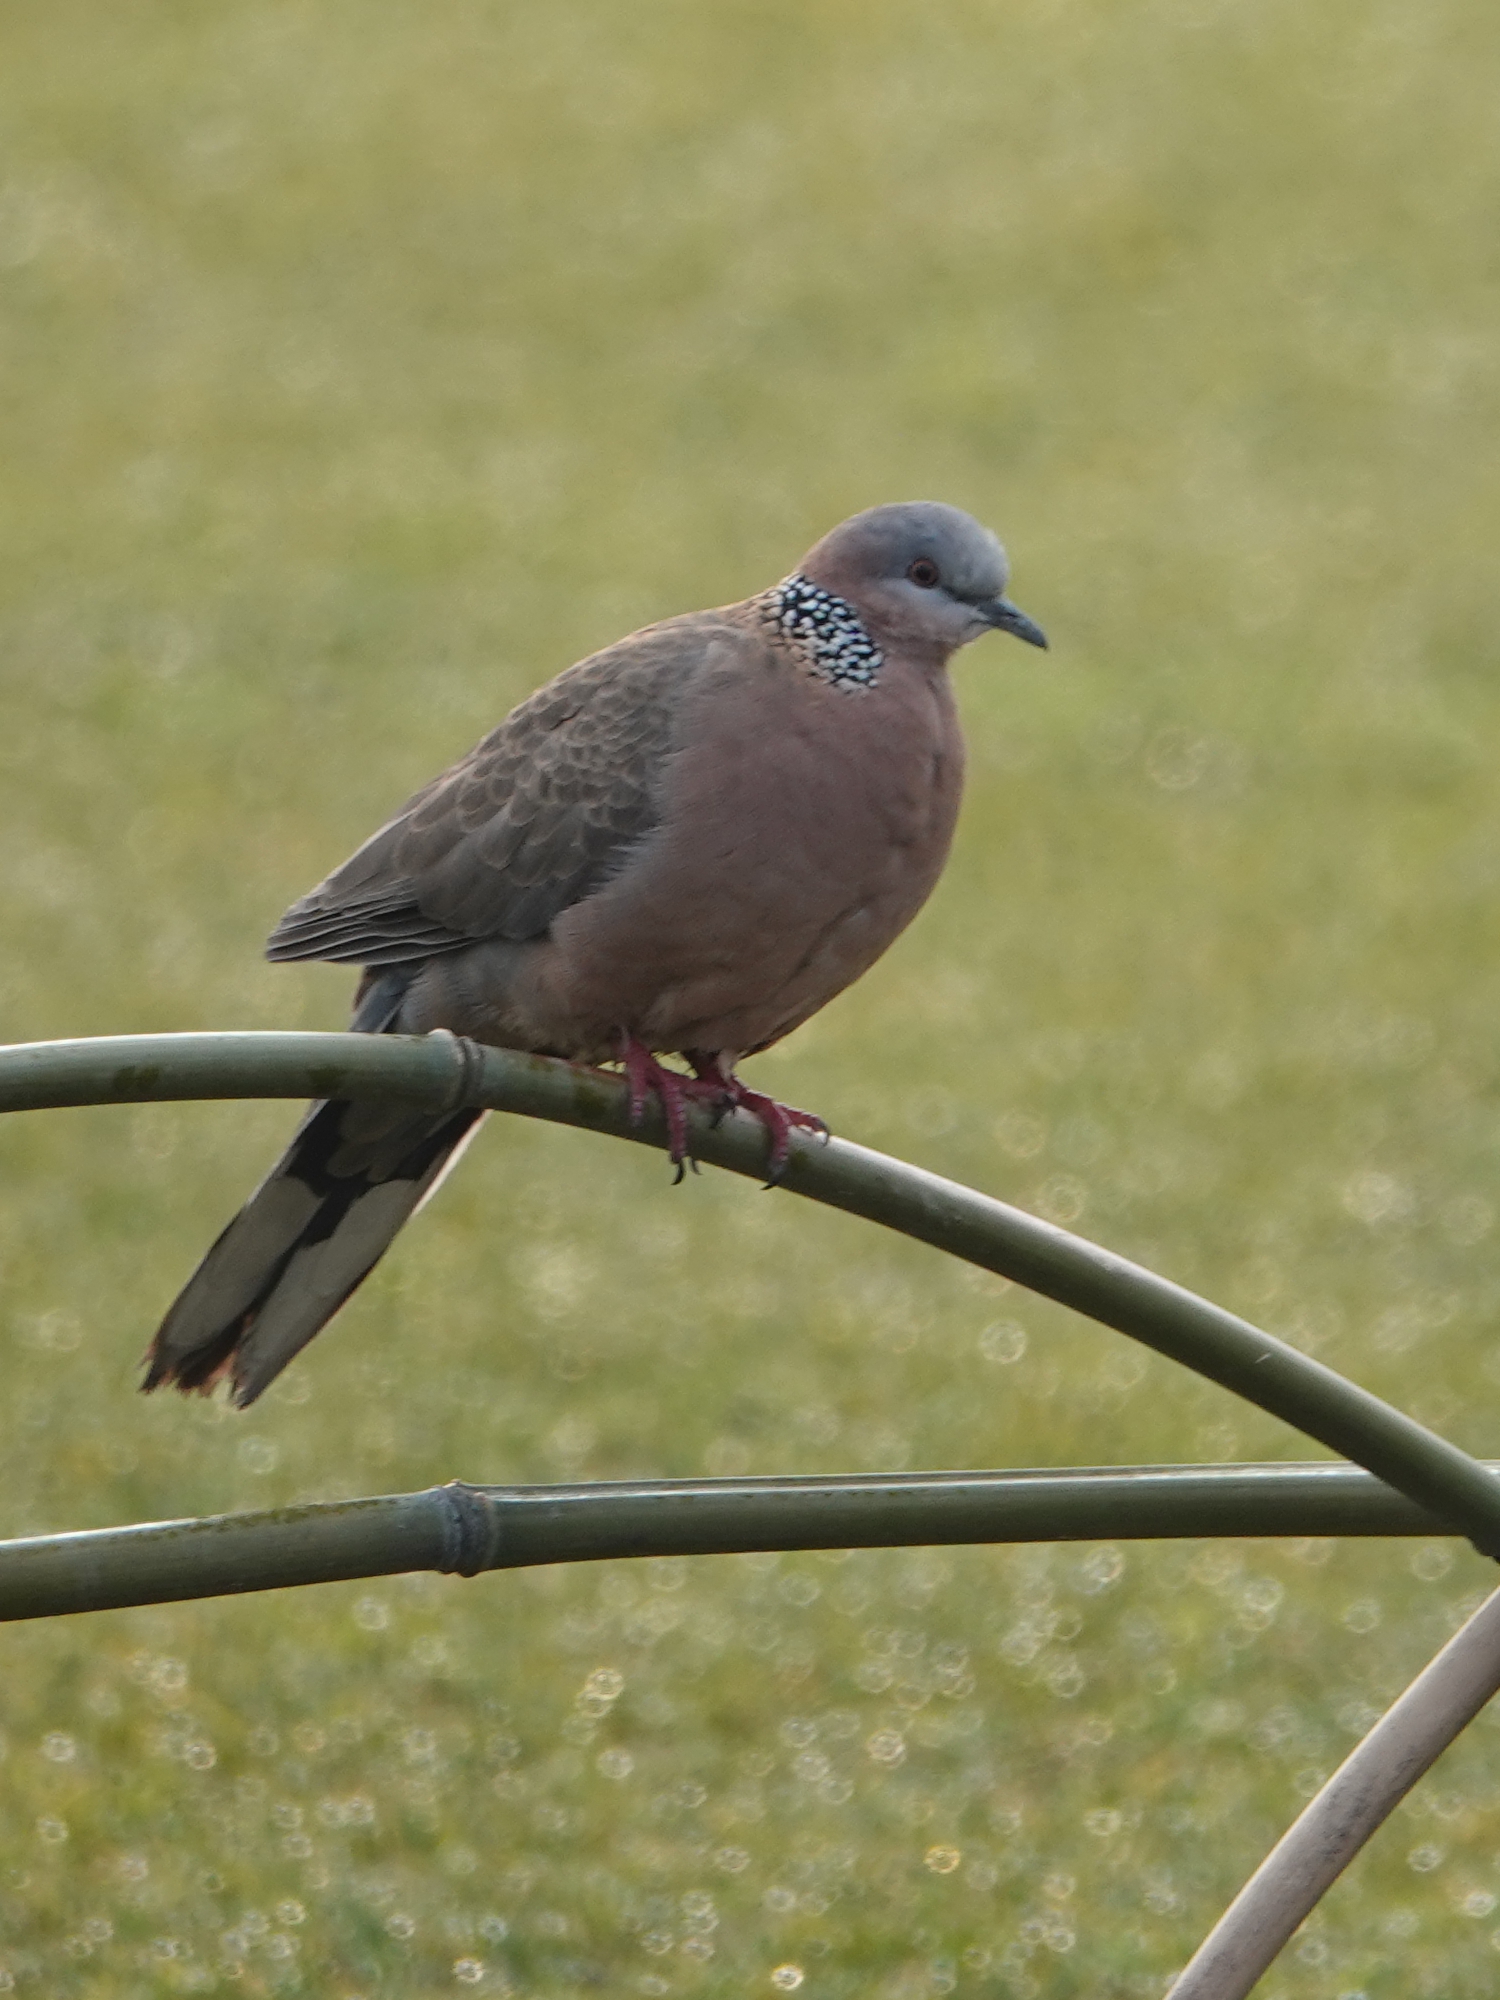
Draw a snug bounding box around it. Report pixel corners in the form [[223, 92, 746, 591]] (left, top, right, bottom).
[[0, 1464, 1488, 1620]]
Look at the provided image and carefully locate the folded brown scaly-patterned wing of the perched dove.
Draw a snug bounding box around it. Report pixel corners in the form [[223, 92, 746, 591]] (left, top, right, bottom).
[[266, 612, 728, 966]]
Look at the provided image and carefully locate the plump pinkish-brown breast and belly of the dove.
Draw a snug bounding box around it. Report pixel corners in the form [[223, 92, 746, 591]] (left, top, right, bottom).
[[548, 648, 964, 1054]]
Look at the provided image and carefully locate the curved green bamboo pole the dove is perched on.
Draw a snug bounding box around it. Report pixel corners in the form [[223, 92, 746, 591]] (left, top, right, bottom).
[[0, 1034, 1500, 1554]]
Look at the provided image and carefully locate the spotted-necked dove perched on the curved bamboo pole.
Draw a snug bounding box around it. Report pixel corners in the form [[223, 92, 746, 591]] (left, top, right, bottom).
[[142, 500, 1048, 1408]]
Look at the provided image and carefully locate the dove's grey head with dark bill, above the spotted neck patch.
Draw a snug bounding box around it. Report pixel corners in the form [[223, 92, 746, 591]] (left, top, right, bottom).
[[798, 500, 1046, 660]]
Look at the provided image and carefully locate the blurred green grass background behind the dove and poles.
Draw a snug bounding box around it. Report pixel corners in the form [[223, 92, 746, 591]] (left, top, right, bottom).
[[0, 0, 1500, 2000]]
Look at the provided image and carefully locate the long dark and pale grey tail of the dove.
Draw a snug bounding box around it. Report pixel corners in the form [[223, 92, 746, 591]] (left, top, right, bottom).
[[140, 968, 484, 1410]]
